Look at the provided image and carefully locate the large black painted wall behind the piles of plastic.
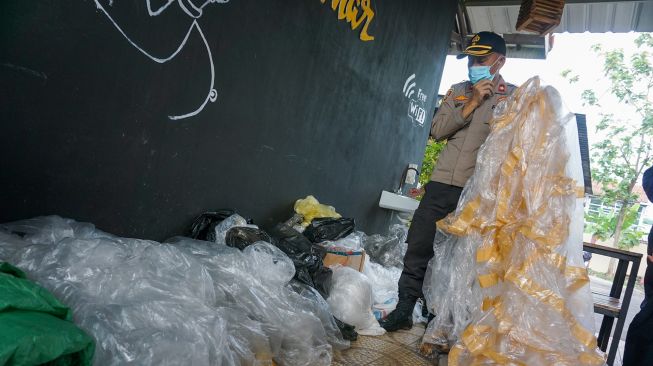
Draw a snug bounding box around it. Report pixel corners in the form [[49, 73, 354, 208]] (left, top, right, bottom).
[[0, 0, 456, 239]]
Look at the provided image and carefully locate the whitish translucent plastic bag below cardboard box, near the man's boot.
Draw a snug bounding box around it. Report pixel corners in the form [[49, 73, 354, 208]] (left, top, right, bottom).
[[327, 266, 385, 335]]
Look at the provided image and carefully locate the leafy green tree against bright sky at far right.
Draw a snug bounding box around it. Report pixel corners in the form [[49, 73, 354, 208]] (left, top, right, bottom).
[[561, 33, 653, 252]]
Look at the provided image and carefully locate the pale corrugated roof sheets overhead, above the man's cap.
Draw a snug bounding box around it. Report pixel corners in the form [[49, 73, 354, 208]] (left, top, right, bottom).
[[466, 1, 653, 34]]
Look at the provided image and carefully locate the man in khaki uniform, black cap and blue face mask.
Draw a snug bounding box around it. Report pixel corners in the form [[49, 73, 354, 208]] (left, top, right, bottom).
[[381, 32, 515, 332]]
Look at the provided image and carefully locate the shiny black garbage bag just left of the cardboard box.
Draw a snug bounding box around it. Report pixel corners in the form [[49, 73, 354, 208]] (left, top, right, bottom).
[[271, 224, 333, 298]]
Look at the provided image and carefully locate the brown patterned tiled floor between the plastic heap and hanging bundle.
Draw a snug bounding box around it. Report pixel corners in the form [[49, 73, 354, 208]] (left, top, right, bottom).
[[332, 325, 447, 366]]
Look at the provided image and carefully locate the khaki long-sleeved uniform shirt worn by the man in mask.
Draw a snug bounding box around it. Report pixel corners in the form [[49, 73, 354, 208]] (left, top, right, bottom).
[[431, 75, 516, 187]]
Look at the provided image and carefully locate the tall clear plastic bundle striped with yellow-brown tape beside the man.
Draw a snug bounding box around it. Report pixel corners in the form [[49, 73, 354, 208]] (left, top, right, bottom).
[[422, 77, 604, 366]]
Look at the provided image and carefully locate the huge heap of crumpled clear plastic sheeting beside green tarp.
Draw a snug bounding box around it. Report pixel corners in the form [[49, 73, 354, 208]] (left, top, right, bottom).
[[0, 216, 349, 365]]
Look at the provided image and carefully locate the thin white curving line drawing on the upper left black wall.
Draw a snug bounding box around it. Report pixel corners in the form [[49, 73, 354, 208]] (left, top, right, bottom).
[[95, 0, 229, 120]]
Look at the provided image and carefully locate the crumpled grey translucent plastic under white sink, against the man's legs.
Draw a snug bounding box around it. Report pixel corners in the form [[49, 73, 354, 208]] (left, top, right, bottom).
[[360, 224, 408, 269]]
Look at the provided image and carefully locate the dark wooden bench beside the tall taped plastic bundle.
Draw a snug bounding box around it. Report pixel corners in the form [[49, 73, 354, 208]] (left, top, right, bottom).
[[583, 243, 642, 366]]
